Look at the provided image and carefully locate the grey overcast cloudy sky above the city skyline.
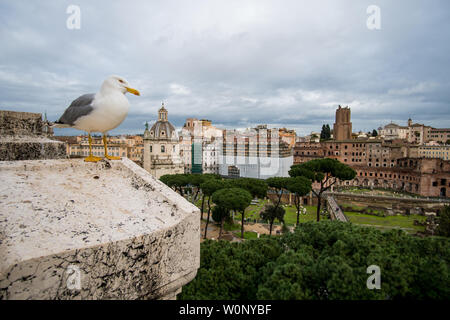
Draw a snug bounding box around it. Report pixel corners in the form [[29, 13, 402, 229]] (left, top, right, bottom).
[[0, 0, 450, 135]]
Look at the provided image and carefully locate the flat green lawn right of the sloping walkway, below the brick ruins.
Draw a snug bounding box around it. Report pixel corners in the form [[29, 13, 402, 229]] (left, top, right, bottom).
[[345, 212, 426, 233]]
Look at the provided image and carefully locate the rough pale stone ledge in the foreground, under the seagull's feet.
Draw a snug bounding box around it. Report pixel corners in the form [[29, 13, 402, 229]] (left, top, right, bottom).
[[0, 159, 200, 299]]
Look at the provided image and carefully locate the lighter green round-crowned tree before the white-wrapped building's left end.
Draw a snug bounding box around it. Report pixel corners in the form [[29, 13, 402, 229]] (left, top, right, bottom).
[[212, 188, 252, 239]]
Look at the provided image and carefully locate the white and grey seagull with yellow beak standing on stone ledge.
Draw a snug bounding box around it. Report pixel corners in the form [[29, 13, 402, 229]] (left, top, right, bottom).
[[53, 75, 140, 162]]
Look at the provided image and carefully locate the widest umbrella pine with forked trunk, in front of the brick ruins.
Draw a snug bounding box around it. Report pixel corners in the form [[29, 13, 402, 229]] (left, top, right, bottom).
[[289, 158, 356, 221]]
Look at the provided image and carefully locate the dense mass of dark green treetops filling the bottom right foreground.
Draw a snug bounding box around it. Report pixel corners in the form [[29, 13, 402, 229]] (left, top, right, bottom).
[[178, 221, 450, 300]]
